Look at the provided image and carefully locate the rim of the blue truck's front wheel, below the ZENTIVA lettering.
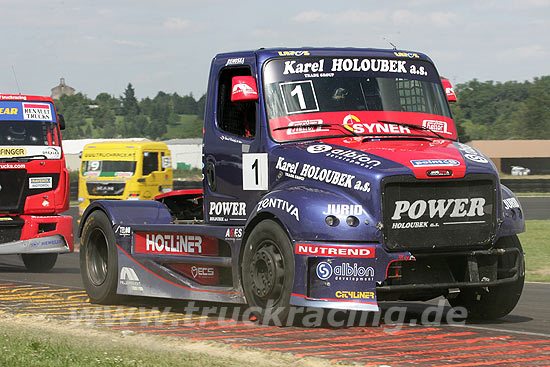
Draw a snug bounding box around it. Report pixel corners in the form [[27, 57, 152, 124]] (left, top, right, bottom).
[[249, 240, 285, 306]]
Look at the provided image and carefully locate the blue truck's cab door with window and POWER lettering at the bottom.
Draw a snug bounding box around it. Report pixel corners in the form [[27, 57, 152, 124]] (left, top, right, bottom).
[[203, 57, 267, 224]]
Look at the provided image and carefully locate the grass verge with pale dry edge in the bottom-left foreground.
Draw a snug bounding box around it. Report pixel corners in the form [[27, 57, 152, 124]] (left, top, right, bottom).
[[0, 315, 330, 367]]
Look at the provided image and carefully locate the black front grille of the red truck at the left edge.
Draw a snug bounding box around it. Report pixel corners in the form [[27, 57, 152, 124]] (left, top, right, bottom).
[[0, 169, 27, 213]]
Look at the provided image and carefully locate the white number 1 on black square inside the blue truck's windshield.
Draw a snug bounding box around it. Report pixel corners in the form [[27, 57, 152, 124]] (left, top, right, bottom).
[[279, 80, 319, 115]]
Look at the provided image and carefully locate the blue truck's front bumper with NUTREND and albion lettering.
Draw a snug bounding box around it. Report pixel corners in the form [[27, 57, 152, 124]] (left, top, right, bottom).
[[290, 242, 525, 311]]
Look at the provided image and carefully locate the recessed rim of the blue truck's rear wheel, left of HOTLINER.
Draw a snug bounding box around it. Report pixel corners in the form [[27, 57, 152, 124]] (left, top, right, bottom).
[[86, 228, 109, 286]]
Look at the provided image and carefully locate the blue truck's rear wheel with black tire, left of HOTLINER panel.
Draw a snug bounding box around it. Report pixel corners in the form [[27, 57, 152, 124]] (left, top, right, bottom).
[[80, 210, 118, 304]]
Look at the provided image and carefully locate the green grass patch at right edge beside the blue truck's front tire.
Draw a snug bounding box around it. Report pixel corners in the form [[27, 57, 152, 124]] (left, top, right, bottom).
[[519, 220, 550, 282]]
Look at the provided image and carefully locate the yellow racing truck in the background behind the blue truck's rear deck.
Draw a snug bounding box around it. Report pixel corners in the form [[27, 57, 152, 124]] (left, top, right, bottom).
[[78, 141, 173, 215]]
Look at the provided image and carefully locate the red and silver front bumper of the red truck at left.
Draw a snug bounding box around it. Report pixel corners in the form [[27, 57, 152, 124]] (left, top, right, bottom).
[[0, 215, 74, 255]]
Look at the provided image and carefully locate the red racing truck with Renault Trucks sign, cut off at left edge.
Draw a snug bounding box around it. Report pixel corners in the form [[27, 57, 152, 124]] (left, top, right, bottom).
[[0, 94, 73, 272]]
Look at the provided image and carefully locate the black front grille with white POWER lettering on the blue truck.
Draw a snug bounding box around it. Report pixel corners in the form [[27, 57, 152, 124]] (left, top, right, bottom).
[[382, 174, 496, 251]]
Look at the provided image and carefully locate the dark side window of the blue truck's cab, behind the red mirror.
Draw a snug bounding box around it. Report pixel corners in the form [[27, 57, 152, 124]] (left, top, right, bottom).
[[218, 67, 256, 138]]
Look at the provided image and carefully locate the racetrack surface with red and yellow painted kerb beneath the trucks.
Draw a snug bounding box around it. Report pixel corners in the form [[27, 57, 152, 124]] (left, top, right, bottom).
[[0, 197, 550, 367]]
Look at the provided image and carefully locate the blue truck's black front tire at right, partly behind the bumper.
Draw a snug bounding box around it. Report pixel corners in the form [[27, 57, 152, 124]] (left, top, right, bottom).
[[449, 235, 525, 320]]
